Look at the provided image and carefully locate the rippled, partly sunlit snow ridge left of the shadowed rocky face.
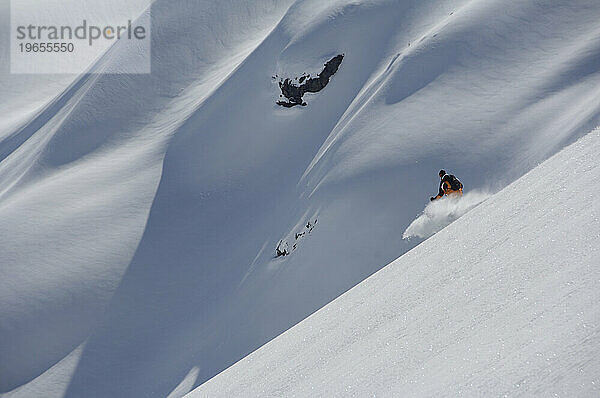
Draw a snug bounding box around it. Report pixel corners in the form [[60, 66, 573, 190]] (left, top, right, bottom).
[[0, 0, 289, 397]]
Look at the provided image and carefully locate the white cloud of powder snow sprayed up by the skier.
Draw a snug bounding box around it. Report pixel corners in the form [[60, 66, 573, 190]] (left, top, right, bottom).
[[402, 191, 490, 239]]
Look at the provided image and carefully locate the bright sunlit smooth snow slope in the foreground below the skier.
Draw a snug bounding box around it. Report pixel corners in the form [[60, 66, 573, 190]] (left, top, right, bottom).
[[189, 130, 600, 397]]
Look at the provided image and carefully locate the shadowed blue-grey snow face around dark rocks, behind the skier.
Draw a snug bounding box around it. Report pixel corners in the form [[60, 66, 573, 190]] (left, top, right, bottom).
[[67, 0, 600, 397]]
